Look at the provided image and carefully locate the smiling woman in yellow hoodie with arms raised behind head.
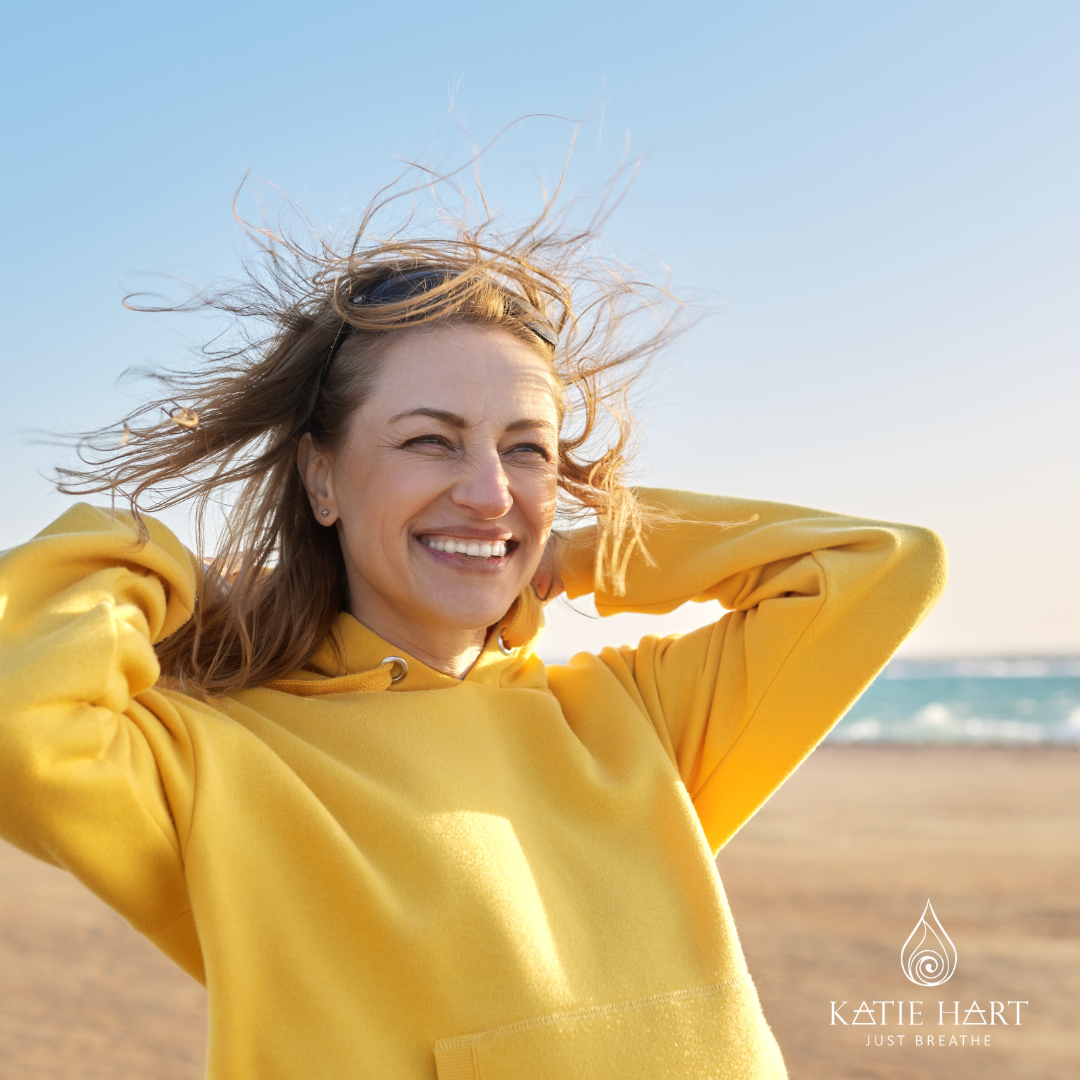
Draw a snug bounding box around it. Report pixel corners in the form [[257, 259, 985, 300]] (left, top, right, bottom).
[[0, 196, 943, 1080]]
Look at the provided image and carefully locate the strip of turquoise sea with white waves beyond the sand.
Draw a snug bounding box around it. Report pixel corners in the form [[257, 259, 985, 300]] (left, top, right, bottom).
[[826, 657, 1080, 746]]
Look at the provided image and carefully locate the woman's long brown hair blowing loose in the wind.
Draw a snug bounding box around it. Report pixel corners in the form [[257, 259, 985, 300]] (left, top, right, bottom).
[[58, 152, 679, 696]]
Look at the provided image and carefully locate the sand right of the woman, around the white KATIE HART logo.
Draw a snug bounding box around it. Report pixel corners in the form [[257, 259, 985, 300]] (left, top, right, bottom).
[[717, 746, 1080, 1080]]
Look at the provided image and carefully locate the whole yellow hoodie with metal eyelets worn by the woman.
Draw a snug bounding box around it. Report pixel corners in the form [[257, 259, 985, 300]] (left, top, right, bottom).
[[0, 491, 944, 1080]]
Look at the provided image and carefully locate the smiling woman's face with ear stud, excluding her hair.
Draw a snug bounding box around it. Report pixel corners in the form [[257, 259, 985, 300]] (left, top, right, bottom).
[[301, 323, 558, 653]]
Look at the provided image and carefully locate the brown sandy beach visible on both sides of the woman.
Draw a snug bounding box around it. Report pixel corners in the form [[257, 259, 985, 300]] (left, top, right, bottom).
[[0, 746, 1080, 1080]]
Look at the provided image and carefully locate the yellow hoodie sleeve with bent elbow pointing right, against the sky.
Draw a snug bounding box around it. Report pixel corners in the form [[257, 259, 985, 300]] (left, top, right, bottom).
[[562, 490, 945, 851]]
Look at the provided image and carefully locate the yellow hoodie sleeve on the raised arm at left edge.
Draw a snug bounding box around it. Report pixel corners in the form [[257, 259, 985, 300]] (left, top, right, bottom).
[[0, 504, 202, 977]]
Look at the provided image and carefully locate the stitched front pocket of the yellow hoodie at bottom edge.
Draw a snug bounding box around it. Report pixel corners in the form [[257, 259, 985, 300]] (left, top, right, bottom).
[[435, 975, 787, 1080]]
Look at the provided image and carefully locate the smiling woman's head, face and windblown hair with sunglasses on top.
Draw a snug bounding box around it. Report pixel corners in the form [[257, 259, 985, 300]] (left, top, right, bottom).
[[52, 200, 677, 694]]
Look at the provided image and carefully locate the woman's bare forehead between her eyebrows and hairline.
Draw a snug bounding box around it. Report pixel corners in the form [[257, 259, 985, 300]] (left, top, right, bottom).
[[368, 323, 561, 427]]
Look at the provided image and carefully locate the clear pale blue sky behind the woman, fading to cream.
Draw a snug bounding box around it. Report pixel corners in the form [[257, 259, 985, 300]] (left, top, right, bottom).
[[0, 2, 1080, 654]]
